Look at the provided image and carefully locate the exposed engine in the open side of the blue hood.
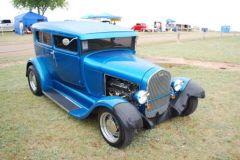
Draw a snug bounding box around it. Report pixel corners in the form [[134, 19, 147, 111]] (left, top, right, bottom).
[[106, 76, 139, 103]]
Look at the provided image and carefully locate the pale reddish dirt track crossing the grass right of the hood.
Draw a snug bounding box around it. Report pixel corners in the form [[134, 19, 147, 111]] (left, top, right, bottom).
[[142, 57, 240, 71]]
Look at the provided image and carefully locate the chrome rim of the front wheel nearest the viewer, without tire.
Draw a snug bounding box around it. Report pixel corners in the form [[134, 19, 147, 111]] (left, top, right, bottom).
[[100, 112, 120, 143]]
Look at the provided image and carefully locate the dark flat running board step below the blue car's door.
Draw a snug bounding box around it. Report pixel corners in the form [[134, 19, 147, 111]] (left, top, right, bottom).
[[43, 89, 82, 112]]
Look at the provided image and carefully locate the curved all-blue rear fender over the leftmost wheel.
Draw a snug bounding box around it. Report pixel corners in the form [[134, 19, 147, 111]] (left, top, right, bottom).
[[26, 57, 53, 91]]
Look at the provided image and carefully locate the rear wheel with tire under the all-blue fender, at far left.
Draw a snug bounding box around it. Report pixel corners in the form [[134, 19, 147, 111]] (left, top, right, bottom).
[[27, 65, 42, 96]]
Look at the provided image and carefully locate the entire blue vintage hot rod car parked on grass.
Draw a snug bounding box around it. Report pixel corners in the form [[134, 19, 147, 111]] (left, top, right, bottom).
[[26, 21, 205, 148]]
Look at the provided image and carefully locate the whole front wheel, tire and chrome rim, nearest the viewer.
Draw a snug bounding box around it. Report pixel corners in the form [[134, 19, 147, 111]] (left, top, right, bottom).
[[98, 108, 135, 148]]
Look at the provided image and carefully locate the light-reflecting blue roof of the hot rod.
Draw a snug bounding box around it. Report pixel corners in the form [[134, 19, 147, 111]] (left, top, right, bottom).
[[32, 21, 138, 40]]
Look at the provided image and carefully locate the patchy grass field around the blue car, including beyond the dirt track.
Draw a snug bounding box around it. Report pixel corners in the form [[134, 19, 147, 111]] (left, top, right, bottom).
[[0, 31, 240, 160]]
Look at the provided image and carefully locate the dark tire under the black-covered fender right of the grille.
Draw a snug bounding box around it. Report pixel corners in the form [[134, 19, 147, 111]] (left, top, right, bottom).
[[181, 97, 198, 116]]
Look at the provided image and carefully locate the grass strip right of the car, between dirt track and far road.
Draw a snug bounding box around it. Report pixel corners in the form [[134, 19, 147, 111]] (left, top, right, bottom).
[[137, 36, 240, 64]]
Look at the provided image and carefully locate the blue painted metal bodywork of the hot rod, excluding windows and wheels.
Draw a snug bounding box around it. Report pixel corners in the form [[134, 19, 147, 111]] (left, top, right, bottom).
[[27, 22, 202, 122]]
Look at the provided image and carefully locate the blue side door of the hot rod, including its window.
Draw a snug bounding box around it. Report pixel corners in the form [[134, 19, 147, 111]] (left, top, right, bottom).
[[49, 35, 82, 88]]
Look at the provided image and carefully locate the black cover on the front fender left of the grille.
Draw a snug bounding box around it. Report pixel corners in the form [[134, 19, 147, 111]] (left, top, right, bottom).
[[112, 102, 143, 129]]
